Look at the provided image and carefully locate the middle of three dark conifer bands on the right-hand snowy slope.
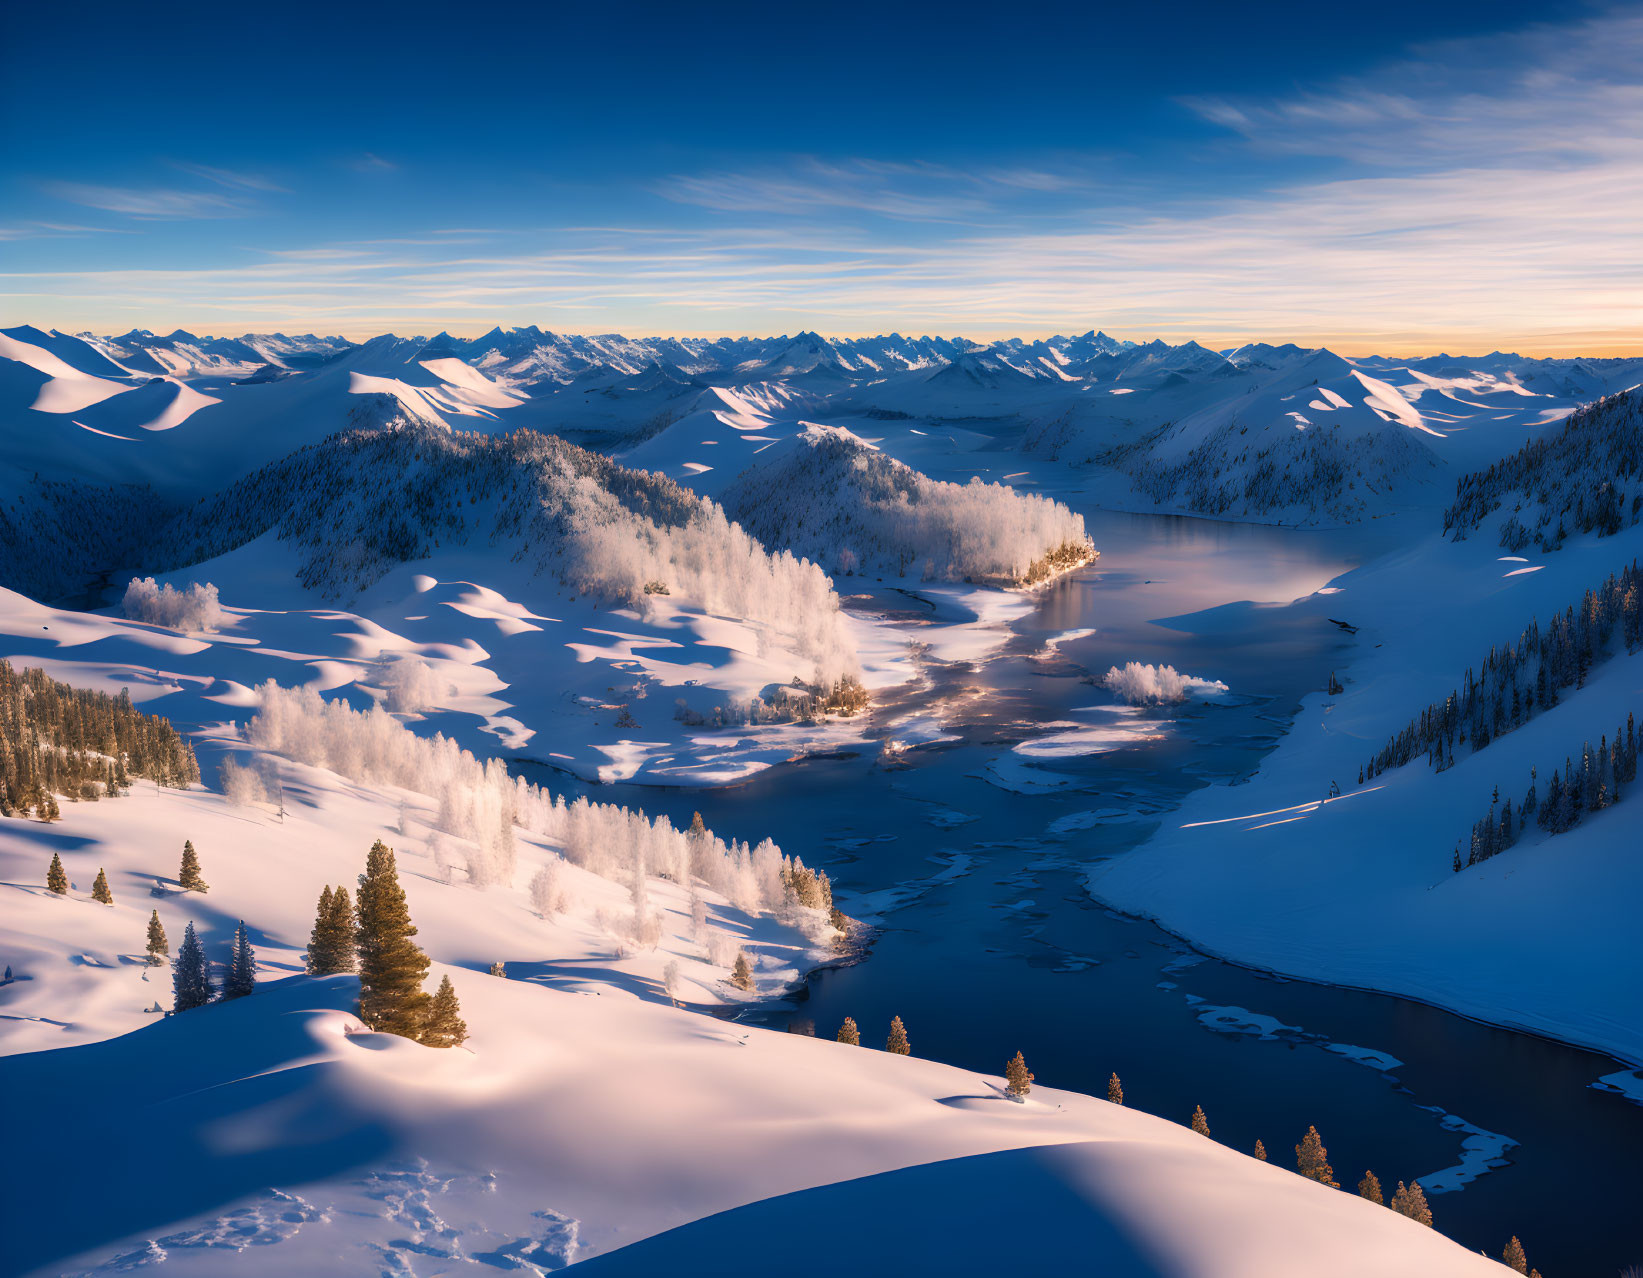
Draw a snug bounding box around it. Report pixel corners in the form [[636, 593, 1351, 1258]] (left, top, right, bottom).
[[1357, 560, 1643, 785]]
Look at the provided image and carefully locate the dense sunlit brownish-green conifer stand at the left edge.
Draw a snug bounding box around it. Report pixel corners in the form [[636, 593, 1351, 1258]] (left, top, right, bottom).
[[0, 660, 200, 820]]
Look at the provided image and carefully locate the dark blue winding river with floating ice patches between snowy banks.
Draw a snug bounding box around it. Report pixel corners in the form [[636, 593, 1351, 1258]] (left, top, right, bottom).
[[542, 516, 1643, 1278]]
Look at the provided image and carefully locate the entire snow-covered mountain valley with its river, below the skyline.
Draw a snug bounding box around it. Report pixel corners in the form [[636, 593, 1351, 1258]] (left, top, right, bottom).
[[0, 325, 1643, 1278]]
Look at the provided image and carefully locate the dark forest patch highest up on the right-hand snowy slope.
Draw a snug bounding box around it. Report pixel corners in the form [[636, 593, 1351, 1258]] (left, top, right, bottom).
[[1443, 389, 1643, 554]]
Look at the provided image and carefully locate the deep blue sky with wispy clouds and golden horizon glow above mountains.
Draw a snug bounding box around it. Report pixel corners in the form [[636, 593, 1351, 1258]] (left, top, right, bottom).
[[0, 0, 1643, 352]]
